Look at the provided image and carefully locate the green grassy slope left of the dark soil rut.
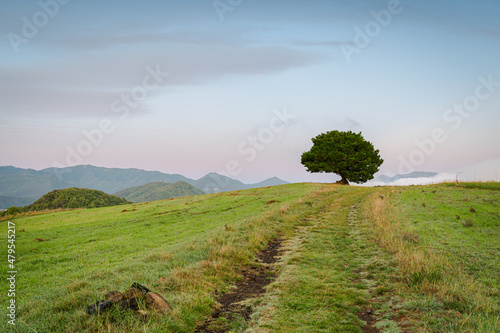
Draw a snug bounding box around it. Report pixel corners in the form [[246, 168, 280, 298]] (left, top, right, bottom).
[[0, 185, 324, 332]]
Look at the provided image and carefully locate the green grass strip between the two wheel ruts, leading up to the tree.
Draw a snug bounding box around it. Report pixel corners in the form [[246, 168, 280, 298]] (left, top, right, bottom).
[[253, 187, 373, 332]]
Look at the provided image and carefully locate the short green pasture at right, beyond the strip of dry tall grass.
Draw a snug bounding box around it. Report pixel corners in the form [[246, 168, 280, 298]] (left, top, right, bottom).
[[398, 184, 500, 292]]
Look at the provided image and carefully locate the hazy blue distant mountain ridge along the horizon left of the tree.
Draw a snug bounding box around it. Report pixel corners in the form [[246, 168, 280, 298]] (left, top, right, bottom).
[[0, 165, 288, 209]]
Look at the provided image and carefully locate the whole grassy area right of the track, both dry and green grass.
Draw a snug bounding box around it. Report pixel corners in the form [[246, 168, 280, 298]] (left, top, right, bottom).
[[366, 184, 500, 333]]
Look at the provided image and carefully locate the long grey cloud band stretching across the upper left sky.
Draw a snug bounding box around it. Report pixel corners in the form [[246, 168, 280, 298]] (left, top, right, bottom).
[[0, 45, 323, 117]]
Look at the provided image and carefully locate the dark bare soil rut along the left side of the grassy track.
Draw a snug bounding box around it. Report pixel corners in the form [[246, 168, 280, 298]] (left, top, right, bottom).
[[195, 238, 283, 333]]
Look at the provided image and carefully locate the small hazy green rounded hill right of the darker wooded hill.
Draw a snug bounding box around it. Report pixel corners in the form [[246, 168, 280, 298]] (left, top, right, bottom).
[[115, 181, 204, 203]]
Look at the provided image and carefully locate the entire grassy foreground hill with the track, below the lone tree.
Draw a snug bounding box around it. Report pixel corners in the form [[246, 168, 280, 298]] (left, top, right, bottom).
[[0, 183, 500, 333]]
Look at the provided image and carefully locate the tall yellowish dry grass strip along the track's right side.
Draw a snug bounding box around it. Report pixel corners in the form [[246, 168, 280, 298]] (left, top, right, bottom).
[[364, 188, 500, 332]]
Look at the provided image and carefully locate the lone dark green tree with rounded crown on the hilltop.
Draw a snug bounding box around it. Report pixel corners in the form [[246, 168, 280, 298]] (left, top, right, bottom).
[[301, 131, 384, 185]]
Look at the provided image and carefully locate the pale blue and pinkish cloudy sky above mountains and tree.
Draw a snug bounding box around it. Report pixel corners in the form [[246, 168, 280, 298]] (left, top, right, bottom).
[[0, 0, 500, 183]]
